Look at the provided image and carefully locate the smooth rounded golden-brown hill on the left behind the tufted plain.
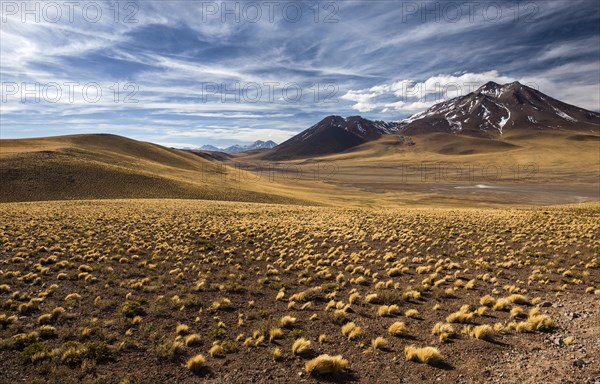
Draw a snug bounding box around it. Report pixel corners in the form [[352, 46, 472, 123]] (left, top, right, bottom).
[[0, 134, 308, 203]]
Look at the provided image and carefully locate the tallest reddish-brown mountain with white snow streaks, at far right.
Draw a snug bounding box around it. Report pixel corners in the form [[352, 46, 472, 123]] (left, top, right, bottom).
[[400, 82, 600, 135]]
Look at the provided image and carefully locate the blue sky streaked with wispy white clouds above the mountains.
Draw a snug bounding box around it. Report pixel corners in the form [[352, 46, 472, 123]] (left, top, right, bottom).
[[0, 0, 600, 147]]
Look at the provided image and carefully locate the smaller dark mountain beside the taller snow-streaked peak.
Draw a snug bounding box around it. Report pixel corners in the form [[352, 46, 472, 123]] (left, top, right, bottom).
[[264, 116, 400, 160]]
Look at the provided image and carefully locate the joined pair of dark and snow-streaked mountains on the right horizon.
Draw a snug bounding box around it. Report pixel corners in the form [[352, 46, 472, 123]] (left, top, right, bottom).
[[261, 82, 600, 160]]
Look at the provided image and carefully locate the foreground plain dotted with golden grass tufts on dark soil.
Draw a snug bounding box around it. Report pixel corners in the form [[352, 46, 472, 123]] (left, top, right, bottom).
[[0, 200, 600, 383]]
